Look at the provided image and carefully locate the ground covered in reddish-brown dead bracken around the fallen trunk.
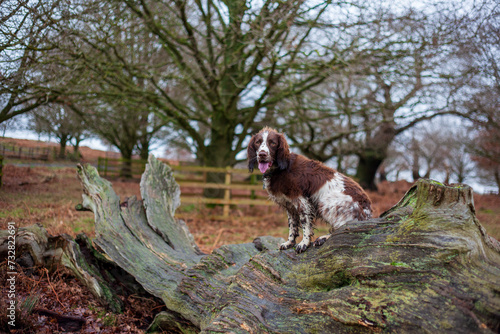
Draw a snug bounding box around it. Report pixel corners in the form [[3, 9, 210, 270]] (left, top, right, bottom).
[[0, 141, 500, 333]]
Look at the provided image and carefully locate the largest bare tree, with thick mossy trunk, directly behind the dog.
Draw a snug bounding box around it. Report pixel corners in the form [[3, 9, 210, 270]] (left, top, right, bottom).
[[45, 0, 349, 172]]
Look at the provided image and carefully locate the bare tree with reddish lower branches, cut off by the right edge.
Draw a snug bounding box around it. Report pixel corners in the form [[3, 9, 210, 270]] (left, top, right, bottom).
[[455, 0, 500, 192]]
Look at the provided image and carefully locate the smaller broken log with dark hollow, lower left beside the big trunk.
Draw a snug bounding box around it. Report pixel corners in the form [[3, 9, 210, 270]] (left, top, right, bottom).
[[0, 224, 150, 313]]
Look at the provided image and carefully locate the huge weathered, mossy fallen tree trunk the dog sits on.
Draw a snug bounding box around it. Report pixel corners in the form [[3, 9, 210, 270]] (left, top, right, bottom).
[[3, 157, 500, 333]]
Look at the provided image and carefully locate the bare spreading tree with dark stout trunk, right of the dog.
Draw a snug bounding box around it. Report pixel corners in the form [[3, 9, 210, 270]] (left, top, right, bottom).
[[283, 2, 478, 189]]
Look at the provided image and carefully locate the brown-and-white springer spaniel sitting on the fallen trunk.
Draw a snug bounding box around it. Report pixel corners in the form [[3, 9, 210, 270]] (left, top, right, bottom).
[[247, 127, 372, 253]]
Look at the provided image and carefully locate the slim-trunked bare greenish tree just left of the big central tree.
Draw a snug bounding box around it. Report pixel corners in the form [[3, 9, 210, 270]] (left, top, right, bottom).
[[28, 0, 169, 177]]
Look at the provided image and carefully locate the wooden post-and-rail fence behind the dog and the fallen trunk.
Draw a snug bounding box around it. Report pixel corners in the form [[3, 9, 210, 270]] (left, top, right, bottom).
[[98, 158, 273, 218]]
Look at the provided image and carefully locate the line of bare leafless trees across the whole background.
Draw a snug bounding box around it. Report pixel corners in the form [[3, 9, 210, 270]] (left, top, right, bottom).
[[0, 0, 500, 193]]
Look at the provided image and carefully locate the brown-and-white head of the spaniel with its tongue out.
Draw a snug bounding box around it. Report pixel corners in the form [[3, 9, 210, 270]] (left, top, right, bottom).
[[247, 127, 290, 173]]
